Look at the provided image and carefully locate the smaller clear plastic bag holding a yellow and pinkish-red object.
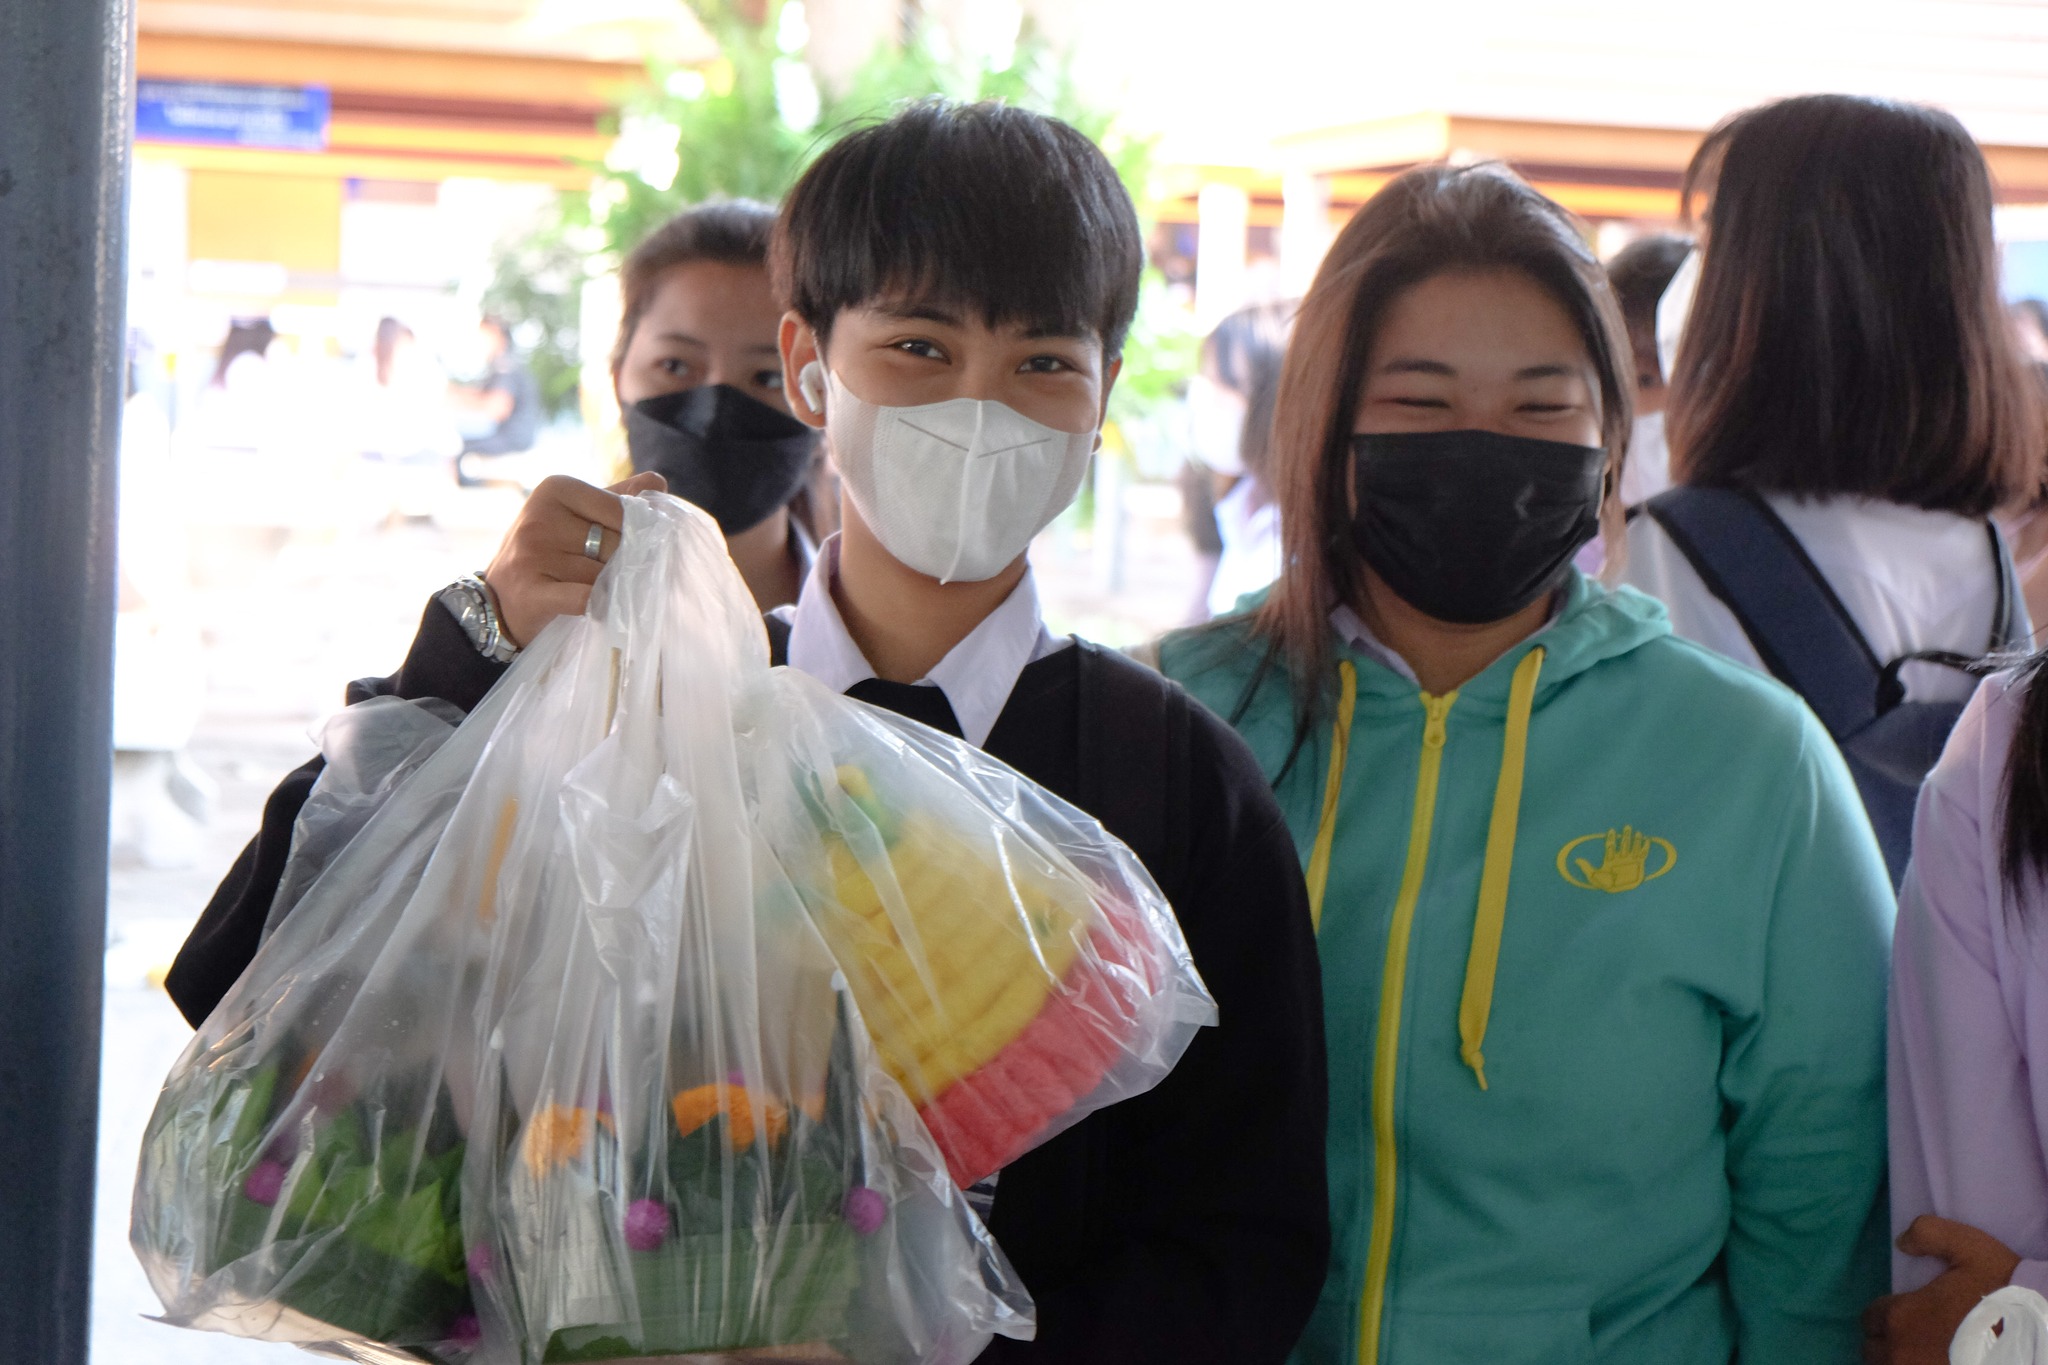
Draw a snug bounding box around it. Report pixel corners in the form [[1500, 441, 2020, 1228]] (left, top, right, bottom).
[[760, 669, 1217, 1187]]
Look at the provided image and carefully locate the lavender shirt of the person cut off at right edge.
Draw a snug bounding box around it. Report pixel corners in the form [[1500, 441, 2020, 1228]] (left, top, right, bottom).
[[1888, 677, 2048, 1291]]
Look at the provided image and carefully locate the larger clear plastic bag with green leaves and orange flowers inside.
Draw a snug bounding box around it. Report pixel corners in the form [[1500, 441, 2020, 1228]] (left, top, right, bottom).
[[131, 495, 1040, 1365]]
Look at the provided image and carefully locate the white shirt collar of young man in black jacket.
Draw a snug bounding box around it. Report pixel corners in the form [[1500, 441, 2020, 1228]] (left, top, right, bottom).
[[780, 536, 1073, 749]]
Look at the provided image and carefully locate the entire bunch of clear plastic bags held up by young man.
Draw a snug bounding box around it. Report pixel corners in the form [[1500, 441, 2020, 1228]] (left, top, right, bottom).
[[133, 495, 1214, 1365]]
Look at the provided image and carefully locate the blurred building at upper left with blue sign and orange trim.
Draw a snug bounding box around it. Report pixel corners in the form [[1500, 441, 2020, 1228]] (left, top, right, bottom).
[[131, 0, 715, 411]]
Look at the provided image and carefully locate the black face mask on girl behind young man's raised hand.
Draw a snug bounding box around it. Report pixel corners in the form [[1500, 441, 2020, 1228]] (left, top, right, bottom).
[[627, 385, 817, 536]]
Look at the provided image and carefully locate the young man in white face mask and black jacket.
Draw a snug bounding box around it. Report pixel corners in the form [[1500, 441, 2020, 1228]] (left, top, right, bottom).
[[170, 102, 1329, 1365]]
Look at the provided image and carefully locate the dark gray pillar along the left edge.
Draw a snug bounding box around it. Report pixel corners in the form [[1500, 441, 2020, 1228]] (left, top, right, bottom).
[[0, 0, 135, 1365]]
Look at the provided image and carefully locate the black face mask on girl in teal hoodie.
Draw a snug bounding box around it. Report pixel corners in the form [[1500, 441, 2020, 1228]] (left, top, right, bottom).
[[1352, 432, 1608, 626]]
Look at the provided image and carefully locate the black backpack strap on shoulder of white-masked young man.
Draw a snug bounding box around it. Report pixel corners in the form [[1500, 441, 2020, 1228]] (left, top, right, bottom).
[[1073, 641, 1190, 896]]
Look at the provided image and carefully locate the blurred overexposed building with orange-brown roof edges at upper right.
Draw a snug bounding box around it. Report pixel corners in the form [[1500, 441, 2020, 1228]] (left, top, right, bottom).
[[1077, 0, 2048, 319]]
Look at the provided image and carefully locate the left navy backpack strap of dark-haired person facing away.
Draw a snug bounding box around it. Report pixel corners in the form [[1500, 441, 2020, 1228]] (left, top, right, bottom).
[[1645, 487, 1884, 741]]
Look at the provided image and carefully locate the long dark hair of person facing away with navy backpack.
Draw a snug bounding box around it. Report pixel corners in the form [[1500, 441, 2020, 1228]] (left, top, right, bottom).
[[1667, 94, 2048, 516]]
